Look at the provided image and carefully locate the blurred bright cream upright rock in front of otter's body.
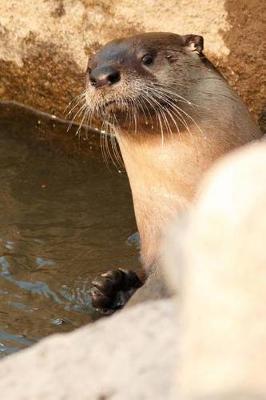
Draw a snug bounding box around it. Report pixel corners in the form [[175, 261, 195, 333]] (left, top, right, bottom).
[[178, 143, 266, 400]]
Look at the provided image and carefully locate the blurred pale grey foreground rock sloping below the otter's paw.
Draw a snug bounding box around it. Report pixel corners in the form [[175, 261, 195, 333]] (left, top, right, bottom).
[[0, 300, 178, 400]]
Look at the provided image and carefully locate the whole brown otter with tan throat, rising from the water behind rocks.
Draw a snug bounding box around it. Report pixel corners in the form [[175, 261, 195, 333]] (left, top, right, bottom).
[[86, 32, 262, 311]]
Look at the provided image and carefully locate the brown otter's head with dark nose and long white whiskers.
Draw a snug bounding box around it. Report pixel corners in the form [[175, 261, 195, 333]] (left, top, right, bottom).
[[86, 33, 203, 131]]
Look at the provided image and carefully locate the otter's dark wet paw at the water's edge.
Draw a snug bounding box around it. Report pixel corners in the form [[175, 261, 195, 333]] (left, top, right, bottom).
[[90, 268, 142, 314]]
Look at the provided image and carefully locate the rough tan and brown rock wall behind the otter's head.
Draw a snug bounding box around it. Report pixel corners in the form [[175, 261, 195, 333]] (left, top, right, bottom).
[[0, 0, 266, 116]]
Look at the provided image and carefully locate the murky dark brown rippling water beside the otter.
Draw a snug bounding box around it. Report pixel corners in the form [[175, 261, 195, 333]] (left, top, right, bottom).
[[0, 104, 138, 357]]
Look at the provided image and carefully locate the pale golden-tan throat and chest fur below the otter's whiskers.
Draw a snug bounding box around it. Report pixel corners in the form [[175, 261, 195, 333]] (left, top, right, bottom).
[[117, 132, 230, 270]]
